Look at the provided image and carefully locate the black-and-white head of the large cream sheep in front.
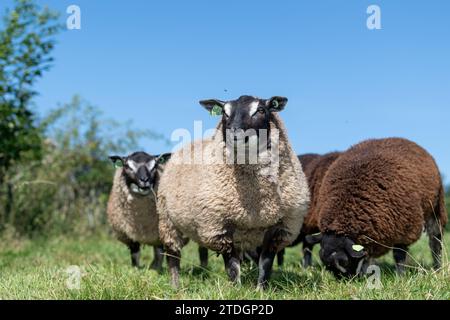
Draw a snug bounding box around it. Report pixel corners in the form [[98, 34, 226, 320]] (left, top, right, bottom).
[[200, 96, 287, 154]]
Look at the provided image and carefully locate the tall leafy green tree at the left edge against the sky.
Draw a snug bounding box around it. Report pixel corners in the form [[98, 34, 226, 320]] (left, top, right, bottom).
[[0, 0, 61, 181]]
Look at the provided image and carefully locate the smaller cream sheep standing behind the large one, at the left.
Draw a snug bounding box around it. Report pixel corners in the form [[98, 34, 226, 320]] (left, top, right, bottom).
[[107, 152, 208, 270]]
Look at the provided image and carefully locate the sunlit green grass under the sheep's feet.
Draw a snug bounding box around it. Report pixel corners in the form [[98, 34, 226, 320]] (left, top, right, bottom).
[[0, 230, 450, 300]]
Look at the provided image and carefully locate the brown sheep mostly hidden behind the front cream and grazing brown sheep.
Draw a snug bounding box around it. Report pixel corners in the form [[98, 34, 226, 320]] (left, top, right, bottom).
[[277, 152, 341, 268]]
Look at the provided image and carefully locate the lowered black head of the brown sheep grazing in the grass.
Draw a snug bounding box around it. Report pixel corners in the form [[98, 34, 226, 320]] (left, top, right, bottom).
[[306, 233, 366, 278]]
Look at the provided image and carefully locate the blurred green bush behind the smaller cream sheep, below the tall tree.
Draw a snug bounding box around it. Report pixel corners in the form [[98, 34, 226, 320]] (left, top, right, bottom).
[[0, 97, 167, 236]]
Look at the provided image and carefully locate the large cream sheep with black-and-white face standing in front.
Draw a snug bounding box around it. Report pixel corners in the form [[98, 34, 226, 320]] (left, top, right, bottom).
[[158, 96, 309, 289]]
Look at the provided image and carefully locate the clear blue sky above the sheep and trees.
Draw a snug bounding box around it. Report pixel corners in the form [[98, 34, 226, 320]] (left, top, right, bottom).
[[0, 0, 450, 182]]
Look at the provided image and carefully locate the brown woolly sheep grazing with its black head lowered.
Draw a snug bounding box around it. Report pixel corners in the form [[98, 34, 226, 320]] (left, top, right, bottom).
[[307, 138, 447, 278]]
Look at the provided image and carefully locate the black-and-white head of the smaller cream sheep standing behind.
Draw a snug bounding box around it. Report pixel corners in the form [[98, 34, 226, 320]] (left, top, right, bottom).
[[110, 152, 170, 196]]
